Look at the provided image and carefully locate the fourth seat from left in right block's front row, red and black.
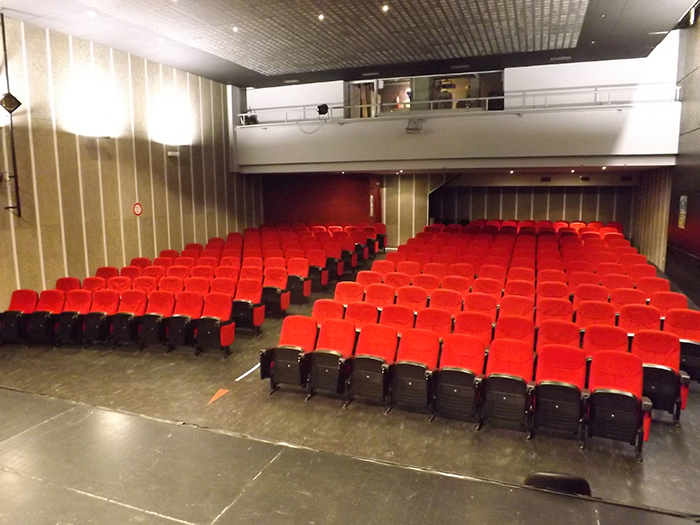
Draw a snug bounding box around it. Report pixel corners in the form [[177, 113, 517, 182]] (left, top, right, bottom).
[[386, 328, 440, 415]]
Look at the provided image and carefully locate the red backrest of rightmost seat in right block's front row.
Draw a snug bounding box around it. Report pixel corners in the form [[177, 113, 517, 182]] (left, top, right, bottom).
[[588, 350, 643, 399]]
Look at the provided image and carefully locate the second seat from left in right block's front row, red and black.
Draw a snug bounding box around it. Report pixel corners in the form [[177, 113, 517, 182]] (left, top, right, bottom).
[[306, 319, 355, 400]]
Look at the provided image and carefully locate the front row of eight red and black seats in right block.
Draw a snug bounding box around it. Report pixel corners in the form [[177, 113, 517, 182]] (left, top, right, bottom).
[[260, 313, 660, 460]]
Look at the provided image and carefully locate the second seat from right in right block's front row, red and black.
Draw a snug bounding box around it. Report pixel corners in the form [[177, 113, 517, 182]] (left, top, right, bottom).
[[532, 344, 587, 448]]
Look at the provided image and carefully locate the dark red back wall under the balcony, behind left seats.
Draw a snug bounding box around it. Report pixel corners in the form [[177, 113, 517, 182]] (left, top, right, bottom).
[[263, 174, 373, 224]]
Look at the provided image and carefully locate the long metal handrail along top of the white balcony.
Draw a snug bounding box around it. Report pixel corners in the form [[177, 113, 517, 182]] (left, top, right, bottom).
[[237, 83, 680, 125]]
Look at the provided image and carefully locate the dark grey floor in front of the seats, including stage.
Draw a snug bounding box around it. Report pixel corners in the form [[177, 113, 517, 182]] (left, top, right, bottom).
[[0, 260, 700, 524]]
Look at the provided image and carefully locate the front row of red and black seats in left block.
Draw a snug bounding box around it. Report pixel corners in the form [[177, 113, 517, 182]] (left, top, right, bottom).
[[0, 289, 235, 356]]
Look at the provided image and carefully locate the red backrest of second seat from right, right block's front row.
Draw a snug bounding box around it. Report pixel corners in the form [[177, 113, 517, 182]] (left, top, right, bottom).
[[535, 344, 586, 391]]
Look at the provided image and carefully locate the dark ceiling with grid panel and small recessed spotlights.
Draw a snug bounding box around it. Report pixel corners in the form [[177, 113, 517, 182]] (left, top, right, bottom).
[[2, 0, 695, 87]]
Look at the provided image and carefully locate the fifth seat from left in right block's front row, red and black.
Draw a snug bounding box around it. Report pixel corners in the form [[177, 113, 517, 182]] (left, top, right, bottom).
[[433, 333, 486, 421]]
